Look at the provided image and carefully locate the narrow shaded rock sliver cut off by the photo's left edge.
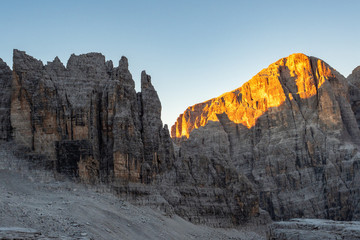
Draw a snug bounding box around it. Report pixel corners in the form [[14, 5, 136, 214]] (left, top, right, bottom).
[[0, 58, 12, 140]]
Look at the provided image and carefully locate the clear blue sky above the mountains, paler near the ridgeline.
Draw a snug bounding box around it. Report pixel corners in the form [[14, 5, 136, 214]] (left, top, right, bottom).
[[0, 0, 360, 126]]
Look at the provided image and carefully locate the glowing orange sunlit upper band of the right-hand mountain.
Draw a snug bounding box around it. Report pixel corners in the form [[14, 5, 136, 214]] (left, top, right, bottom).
[[171, 53, 334, 138]]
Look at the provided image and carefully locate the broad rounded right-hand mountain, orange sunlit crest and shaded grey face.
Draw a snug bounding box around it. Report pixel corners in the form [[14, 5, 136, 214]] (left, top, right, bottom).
[[172, 54, 360, 220]]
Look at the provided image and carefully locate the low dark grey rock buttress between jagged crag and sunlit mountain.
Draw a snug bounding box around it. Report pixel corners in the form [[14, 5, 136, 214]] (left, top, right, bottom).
[[159, 122, 259, 227]]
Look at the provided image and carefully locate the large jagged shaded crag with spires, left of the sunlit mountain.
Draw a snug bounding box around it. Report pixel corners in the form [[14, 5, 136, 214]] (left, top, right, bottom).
[[11, 50, 173, 183]]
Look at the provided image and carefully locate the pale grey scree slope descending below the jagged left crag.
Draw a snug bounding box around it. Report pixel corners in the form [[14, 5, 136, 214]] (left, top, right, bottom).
[[0, 143, 266, 239]]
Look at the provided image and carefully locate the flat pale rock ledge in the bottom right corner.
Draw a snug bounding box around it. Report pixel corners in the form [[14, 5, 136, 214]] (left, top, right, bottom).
[[268, 219, 360, 240]]
